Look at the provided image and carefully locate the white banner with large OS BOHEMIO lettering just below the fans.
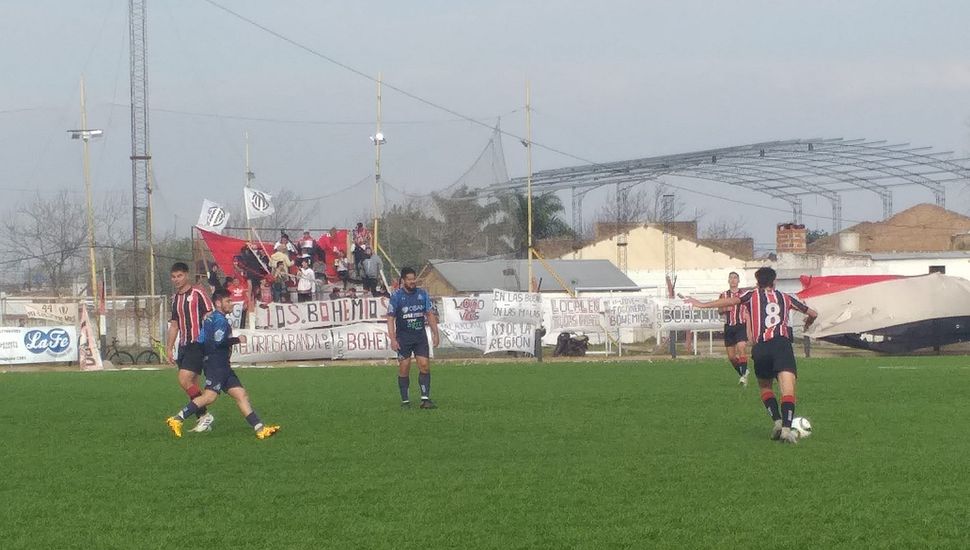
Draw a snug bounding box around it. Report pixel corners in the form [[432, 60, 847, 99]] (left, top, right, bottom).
[[253, 297, 387, 330]]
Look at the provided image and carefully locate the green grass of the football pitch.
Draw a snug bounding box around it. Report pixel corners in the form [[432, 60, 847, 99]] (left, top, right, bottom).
[[0, 357, 970, 550]]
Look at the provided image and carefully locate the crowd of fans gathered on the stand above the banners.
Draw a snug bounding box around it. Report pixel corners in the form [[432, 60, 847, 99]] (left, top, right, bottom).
[[199, 223, 390, 326]]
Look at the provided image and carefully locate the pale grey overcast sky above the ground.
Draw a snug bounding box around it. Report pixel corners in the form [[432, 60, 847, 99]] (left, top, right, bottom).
[[0, 0, 970, 250]]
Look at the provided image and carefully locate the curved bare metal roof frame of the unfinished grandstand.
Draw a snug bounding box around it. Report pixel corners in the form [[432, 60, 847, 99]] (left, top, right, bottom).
[[477, 138, 970, 232]]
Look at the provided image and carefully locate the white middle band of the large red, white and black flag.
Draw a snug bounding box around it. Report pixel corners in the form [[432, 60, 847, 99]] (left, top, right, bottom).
[[805, 273, 970, 338]]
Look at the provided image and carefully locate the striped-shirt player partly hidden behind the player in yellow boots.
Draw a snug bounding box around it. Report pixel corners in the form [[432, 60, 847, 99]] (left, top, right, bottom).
[[165, 262, 215, 432]]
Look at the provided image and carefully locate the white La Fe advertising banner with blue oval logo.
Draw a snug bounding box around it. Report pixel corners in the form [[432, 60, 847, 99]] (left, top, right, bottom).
[[0, 326, 78, 365]]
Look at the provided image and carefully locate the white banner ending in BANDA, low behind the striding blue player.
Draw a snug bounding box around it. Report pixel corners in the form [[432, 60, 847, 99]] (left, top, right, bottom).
[[232, 329, 334, 363]]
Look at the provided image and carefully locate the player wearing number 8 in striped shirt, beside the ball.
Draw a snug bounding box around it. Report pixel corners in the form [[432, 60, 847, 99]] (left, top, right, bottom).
[[688, 267, 818, 443]]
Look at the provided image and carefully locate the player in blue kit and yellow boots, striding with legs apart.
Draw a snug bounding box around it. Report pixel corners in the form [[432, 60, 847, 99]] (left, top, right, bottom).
[[165, 289, 280, 439]]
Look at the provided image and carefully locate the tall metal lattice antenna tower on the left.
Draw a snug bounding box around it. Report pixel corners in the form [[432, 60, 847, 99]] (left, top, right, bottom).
[[128, 0, 155, 296]]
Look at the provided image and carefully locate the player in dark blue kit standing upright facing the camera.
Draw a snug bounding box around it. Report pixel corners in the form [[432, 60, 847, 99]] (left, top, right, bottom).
[[387, 267, 439, 409]]
